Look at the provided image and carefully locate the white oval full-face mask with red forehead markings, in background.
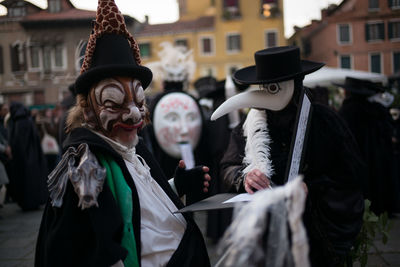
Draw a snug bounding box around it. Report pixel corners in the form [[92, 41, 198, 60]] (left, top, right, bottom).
[[153, 92, 202, 159]]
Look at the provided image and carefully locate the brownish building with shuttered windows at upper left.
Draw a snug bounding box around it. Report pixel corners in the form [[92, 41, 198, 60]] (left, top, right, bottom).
[[0, 0, 138, 107]]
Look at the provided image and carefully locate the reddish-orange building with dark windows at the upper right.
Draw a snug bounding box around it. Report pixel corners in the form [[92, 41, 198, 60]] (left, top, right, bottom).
[[289, 0, 400, 76]]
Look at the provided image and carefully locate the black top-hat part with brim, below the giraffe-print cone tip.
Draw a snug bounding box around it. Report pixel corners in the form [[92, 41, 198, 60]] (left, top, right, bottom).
[[75, 34, 153, 94]]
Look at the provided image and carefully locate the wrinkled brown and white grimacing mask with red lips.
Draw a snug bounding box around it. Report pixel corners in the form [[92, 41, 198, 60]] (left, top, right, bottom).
[[85, 77, 147, 148]]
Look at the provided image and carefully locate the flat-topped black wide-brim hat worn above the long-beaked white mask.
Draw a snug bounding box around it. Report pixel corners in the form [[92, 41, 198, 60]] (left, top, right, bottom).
[[233, 46, 325, 84]]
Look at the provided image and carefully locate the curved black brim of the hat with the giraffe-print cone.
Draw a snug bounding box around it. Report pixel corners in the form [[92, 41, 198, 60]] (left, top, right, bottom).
[[75, 64, 153, 94]]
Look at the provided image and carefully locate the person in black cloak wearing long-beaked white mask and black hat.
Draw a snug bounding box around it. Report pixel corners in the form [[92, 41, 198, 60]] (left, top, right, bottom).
[[212, 46, 364, 266]]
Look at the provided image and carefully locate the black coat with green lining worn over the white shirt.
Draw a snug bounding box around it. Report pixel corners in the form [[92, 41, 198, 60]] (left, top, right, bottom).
[[35, 128, 210, 267]]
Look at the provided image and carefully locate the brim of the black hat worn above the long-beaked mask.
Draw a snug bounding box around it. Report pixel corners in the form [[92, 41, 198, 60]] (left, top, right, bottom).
[[232, 60, 325, 85]]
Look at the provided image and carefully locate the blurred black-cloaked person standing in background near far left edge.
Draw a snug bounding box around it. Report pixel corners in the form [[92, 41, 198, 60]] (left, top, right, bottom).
[[7, 102, 47, 211]]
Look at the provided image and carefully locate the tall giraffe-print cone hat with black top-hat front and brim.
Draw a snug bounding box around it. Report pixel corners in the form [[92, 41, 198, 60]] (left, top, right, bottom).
[[75, 0, 153, 94]]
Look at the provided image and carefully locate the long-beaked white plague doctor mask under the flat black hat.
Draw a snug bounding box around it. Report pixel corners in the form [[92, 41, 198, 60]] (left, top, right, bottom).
[[211, 80, 294, 120]]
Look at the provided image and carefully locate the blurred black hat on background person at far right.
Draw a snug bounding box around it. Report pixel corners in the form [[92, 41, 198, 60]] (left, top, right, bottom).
[[332, 77, 384, 96]]
